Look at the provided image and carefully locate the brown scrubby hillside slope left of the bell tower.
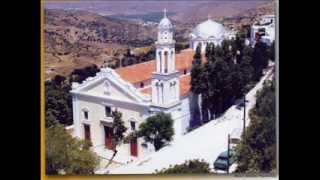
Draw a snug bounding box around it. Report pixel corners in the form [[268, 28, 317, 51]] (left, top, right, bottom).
[[44, 10, 156, 78]]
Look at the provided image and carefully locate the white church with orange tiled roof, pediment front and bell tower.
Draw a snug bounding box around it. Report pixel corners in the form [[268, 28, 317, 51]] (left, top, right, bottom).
[[71, 10, 194, 163]]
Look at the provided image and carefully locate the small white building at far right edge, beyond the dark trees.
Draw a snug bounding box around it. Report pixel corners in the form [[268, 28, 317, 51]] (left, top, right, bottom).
[[250, 15, 275, 45]]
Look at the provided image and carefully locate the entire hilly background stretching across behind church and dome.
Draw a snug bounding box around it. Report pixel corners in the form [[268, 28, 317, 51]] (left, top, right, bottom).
[[44, 0, 275, 79]]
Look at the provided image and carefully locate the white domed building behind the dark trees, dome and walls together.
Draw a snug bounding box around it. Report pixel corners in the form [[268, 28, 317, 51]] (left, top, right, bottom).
[[189, 18, 235, 52]]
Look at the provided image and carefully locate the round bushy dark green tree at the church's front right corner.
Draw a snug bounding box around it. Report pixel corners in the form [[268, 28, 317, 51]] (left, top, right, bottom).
[[138, 112, 174, 151]]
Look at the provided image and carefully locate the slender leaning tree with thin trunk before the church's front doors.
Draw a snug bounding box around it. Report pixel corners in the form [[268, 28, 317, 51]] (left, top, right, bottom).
[[105, 110, 127, 168]]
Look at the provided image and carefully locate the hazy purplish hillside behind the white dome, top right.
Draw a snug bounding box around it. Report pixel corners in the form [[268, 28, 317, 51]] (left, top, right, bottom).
[[173, 0, 276, 29]]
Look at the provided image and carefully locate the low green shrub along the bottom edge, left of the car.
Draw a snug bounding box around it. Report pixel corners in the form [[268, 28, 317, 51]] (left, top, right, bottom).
[[155, 159, 210, 174]]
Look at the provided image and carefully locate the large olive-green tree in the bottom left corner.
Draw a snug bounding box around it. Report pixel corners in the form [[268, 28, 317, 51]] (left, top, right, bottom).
[[46, 124, 99, 175]]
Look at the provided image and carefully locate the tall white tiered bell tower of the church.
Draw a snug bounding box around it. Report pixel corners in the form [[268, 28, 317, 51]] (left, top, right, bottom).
[[151, 9, 180, 107]]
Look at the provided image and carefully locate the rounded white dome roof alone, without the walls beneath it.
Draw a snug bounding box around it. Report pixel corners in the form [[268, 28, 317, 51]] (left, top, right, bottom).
[[191, 19, 226, 39]]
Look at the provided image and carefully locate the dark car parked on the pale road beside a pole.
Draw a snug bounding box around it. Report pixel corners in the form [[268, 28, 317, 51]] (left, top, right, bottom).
[[213, 150, 235, 171]]
